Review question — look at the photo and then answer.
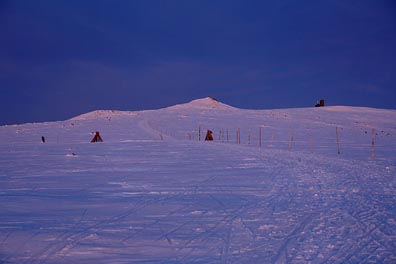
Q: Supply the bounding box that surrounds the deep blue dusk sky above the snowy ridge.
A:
[0,0,396,124]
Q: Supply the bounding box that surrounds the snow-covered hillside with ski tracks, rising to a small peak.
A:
[0,97,396,263]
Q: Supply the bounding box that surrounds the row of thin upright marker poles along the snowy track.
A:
[193,126,375,160]
